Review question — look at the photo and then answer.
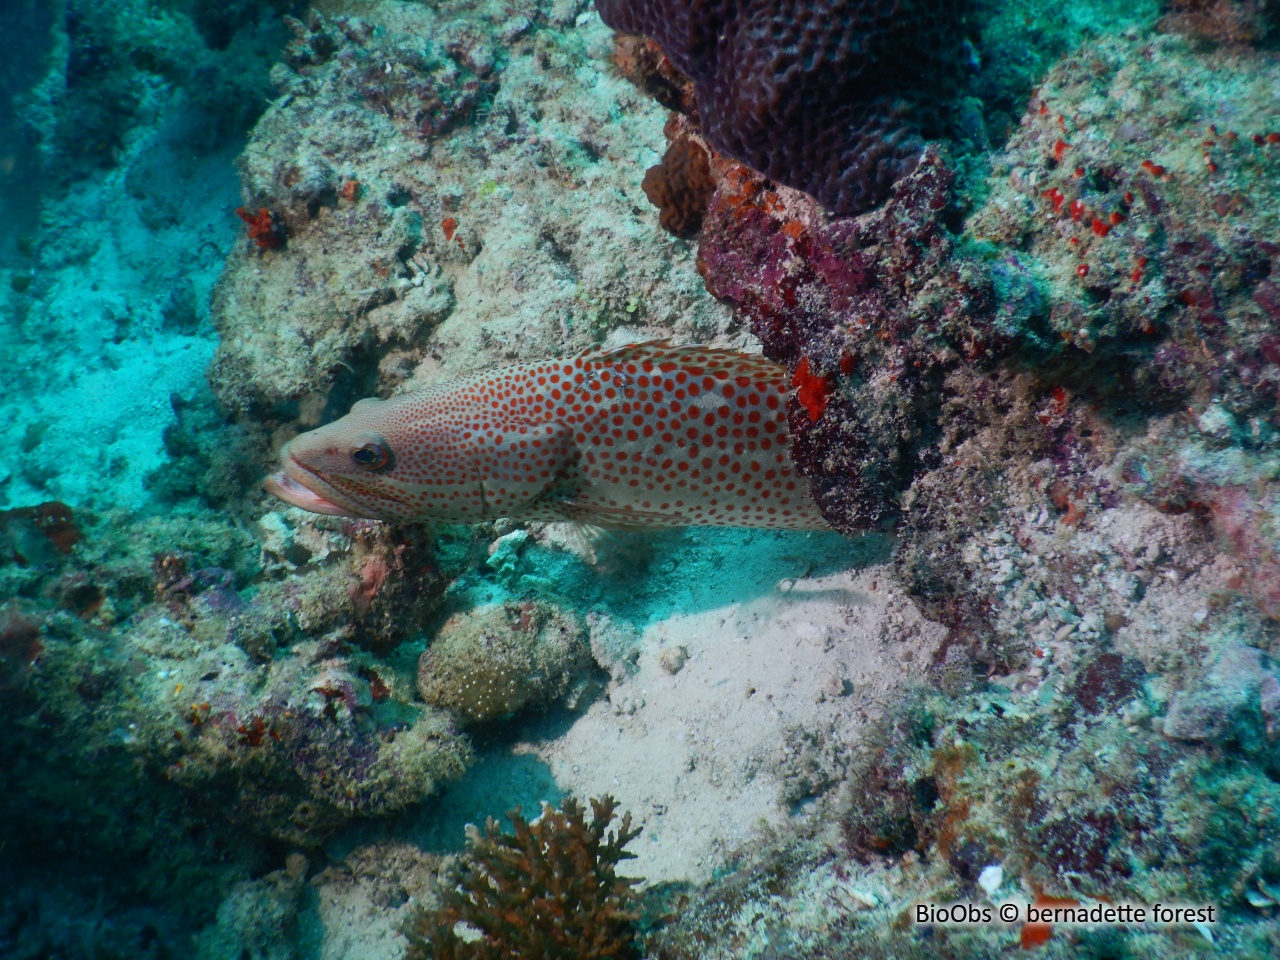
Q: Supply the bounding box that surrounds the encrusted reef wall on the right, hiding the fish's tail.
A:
[640,22,1280,959]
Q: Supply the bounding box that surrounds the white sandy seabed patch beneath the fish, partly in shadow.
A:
[314,526,945,960]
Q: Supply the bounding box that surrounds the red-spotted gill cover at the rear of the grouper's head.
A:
[463,424,573,517]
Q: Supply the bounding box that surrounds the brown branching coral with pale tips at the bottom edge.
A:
[404,796,640,960]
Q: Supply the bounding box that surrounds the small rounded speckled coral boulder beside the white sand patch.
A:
[417,600,590,723]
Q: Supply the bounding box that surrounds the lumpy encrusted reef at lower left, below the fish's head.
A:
[0,504,468,844]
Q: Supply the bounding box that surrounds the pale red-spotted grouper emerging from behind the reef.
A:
[265,340,829,530]
